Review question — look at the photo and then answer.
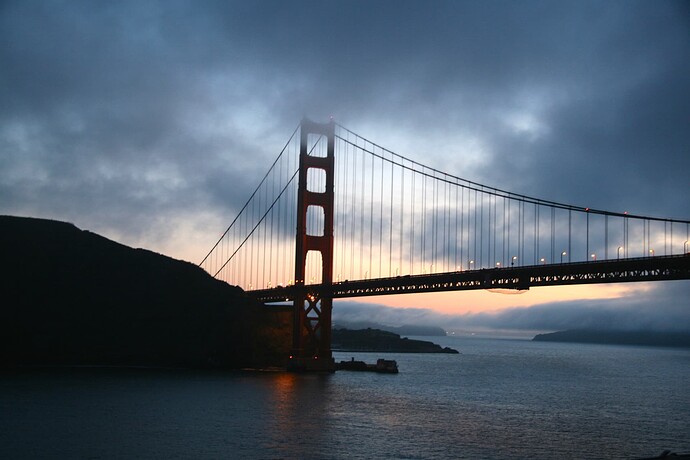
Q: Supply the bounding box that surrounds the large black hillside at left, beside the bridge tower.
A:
[0,216,289,368]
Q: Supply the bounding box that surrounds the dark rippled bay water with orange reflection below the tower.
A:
[0,337,690,459]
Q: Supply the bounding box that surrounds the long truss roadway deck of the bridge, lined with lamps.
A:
[248,253,690,303]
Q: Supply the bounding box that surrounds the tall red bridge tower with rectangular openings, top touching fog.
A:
[288,119,335,372]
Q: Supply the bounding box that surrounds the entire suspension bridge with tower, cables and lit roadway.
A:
[199,120,690,370]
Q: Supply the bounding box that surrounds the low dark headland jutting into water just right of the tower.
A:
[331,328,458,353]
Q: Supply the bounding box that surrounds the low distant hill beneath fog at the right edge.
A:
[532,329,690,347]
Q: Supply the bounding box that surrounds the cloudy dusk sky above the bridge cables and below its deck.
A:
[0,0,690,329]
